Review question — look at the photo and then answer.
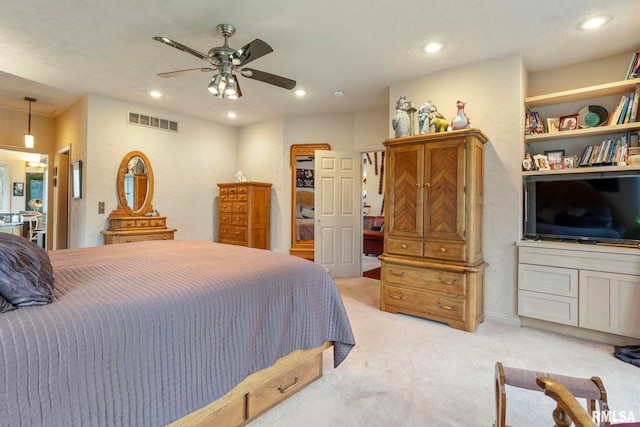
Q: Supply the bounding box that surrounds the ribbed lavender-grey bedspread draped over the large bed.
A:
[0,240,354,426]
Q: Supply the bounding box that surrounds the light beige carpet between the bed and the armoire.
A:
[250,278,640,427]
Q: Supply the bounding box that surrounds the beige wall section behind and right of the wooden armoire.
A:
[387,55,523,322]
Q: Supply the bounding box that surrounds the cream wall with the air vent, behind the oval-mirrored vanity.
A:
[59,94,238,247]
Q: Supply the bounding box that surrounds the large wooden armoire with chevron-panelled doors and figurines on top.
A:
[379,129,488,332]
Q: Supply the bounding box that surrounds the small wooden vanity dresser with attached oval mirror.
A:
[102,151,176,245]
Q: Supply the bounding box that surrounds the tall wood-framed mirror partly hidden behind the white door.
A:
[289,144,331,261]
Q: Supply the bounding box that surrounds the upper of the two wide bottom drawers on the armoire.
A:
[381,262,466,296]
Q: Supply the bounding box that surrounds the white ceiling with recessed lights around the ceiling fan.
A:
[0,0,640,126]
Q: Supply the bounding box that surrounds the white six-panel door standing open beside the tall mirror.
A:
[314,150,362,278]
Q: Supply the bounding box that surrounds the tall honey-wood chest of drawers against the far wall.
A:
[218,182,271,249]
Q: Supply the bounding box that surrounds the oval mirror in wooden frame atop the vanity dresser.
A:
[117,151,153,216]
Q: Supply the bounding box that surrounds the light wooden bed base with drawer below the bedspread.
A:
[169,342,333,427]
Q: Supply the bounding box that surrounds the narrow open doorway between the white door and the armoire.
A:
[362,151,384,279]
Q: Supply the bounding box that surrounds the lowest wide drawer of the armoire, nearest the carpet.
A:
[382,285,465,320]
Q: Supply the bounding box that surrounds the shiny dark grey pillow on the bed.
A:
[0,233,54,307]
